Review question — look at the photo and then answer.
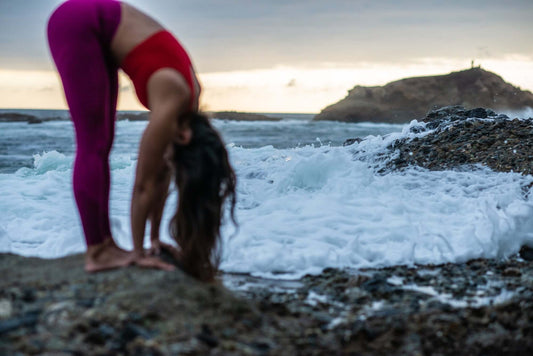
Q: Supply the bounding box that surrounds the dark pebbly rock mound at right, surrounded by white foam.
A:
[380,106,533,174]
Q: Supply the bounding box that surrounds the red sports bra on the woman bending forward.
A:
[121,30,195,109]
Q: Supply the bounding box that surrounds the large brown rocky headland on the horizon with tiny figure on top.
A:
[314,67,533,123]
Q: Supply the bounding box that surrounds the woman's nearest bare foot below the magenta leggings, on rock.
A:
[85,238,133,273]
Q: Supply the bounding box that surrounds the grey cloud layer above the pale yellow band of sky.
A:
[0,0,533,72]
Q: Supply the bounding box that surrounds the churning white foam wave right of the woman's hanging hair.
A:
[217,138,533,278]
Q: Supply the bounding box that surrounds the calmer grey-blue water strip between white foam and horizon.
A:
[0,110,402,173]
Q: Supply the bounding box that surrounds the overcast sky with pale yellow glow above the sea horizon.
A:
[0,0,533,112]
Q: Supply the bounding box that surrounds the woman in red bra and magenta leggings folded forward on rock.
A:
[48,0,235,280]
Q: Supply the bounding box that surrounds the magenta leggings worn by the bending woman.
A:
[48,0,120,245]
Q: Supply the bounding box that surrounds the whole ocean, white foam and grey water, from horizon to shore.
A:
[0,110,533,279]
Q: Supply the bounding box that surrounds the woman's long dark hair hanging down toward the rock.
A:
[170,113,236,281]
